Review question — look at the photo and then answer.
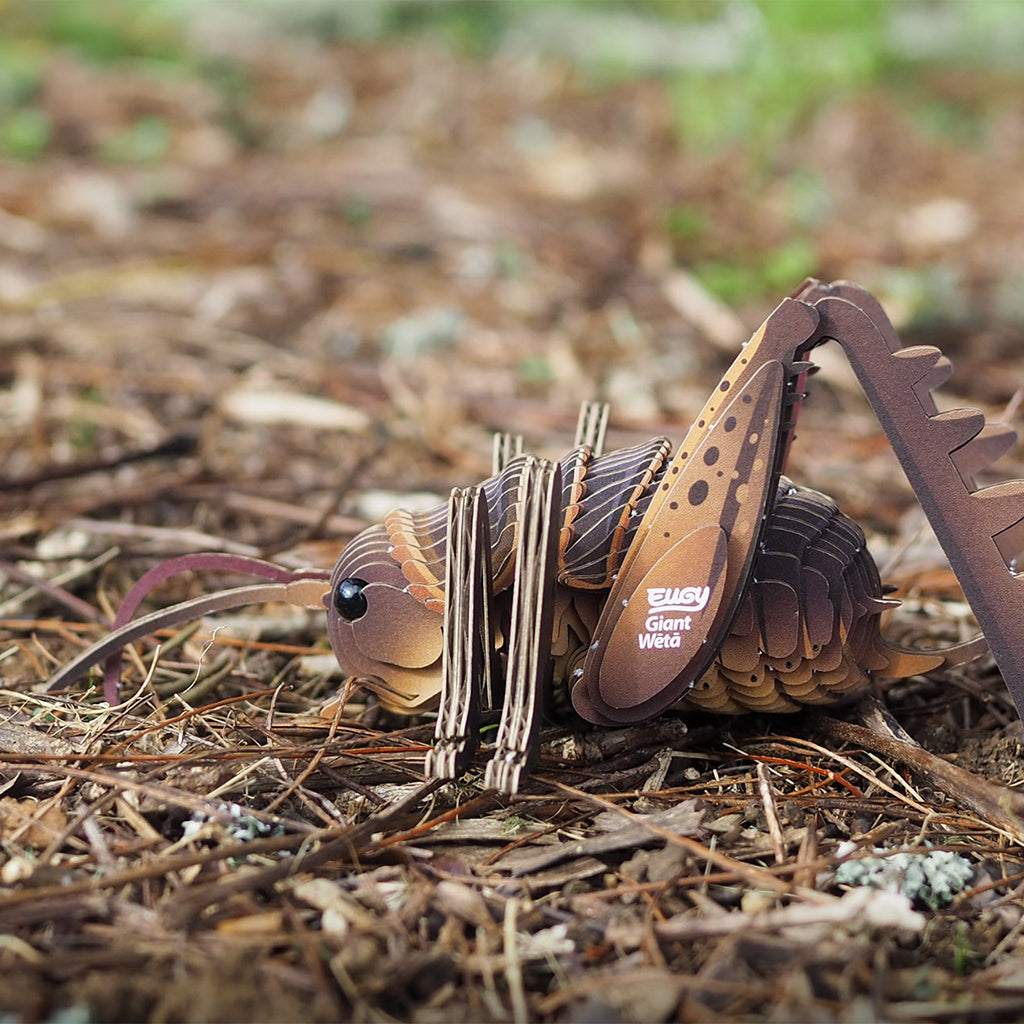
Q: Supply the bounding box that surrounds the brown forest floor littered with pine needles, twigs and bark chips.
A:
[0,10,1024,1021]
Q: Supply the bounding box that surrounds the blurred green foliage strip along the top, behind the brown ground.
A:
[8,0,1024,148]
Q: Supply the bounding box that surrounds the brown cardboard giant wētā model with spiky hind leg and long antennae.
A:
[51,281,1024,792]
